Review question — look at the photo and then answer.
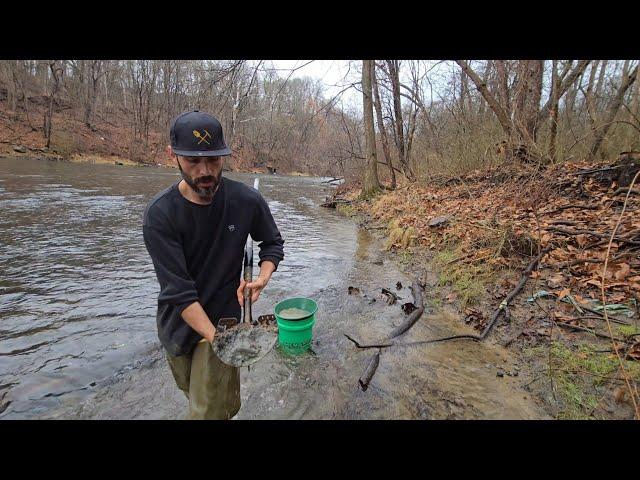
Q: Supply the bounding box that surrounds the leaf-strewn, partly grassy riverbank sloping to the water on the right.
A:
[337,158,640,419]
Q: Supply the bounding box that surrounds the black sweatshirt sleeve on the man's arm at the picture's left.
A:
[142,207,199,314]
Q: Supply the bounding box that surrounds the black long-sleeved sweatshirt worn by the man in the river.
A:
[142,177,284,356]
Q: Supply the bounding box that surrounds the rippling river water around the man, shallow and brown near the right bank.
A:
[0,159,544,419]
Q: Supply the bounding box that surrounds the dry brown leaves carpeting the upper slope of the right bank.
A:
[352,158,640,303]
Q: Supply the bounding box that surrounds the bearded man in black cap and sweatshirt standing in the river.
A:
[143,110,284,419]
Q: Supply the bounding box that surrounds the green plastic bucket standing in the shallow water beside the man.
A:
[274,297,318,355]
